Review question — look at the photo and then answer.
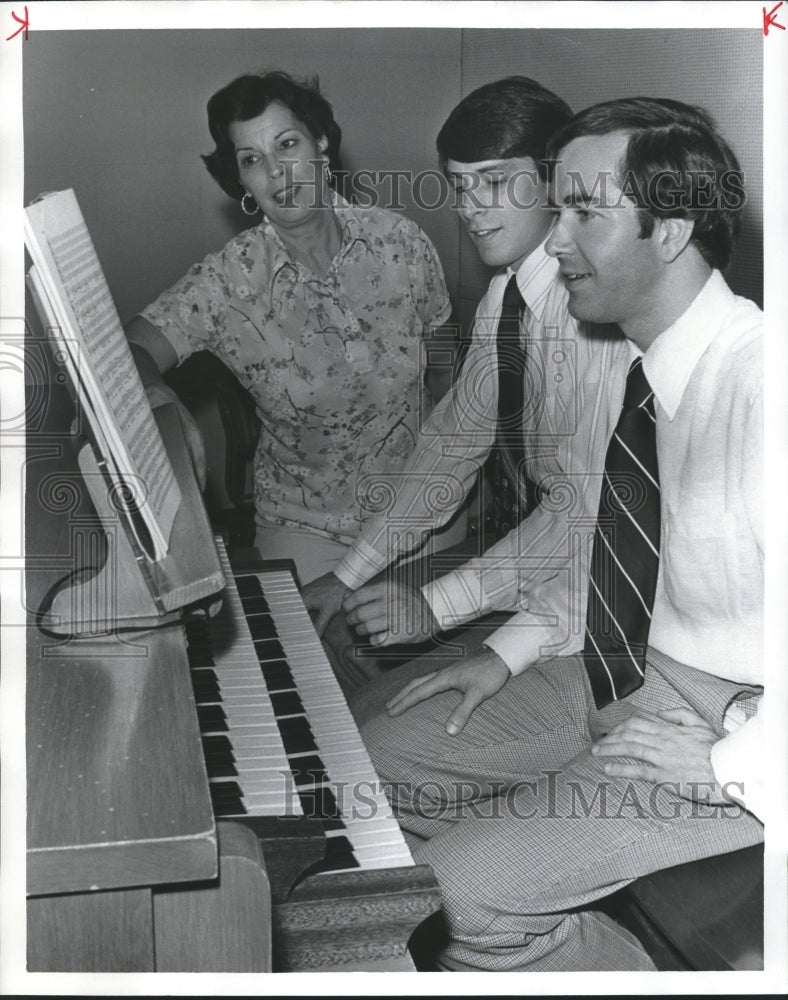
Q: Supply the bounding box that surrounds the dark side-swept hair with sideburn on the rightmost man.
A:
[547,97,745,270]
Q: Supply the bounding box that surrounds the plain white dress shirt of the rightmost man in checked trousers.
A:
[487,271,764,815]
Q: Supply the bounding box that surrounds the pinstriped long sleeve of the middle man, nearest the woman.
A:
[334,292,498,589]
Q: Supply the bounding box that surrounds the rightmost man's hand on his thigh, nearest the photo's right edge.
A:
[591,708,731,804]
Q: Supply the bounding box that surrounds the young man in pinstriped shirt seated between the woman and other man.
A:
[304,76,628,688]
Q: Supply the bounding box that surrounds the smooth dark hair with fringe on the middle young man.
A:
[436,76,572,177]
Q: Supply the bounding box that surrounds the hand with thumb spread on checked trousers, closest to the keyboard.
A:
[386,649,511,736]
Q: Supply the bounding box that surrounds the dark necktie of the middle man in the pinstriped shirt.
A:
[485,275,535,541]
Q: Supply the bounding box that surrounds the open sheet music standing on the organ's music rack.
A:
[25,190,181,561]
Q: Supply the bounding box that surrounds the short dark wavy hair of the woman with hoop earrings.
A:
[202,70,342,200]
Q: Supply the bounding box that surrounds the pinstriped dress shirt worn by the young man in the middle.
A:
[334,244,629,628]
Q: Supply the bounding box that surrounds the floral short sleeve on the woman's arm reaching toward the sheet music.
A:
[141,253,231,364]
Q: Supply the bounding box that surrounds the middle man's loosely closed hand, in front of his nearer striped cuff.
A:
[342,580,440,646]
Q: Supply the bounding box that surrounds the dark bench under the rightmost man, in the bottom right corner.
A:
[604,844,763,971]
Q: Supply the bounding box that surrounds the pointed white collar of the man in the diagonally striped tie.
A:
[643,271,735,420]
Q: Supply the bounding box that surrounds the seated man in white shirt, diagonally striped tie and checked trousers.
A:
[363,98,765,971]
